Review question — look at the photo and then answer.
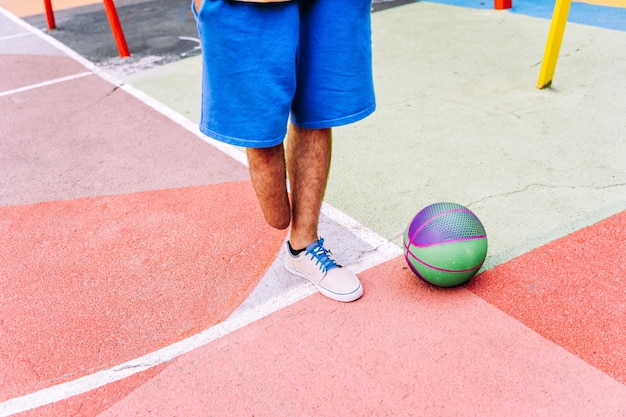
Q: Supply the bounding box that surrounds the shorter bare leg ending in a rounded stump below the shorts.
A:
[246,143,291,229]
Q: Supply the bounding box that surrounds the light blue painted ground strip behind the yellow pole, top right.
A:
[426,0,626,32]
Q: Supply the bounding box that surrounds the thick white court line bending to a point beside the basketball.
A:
[0,7,402,417]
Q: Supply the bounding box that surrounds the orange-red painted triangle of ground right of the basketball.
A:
[468,211,626,384]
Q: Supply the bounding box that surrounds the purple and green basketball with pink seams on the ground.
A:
[404,203,487,287]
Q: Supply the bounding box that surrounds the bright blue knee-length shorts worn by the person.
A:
[192,0,376,148]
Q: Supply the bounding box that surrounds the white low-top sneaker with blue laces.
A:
[285,238,363,303]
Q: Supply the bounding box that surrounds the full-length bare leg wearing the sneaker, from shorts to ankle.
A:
[287,124,332,249]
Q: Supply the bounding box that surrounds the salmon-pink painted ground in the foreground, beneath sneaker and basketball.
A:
[97,258,626,416]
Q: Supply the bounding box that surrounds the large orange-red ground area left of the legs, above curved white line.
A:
[0,181,285,401]
